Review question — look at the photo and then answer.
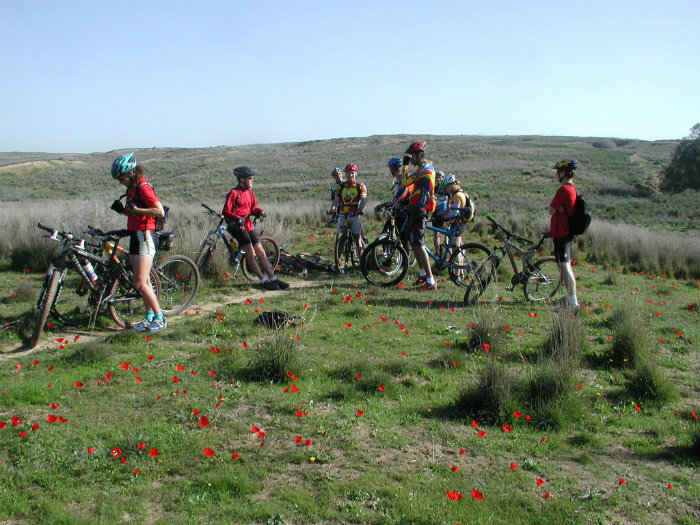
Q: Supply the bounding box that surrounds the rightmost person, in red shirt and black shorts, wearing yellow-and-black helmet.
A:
[549,159,578,308]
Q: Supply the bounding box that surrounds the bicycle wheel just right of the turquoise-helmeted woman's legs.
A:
[155,255,199,315]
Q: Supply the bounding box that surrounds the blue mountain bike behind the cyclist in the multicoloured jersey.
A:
[360,208,489,287]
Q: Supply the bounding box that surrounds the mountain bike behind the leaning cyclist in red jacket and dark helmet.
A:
[195,203,280,281]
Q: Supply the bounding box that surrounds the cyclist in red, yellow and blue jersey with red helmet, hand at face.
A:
[401,142,437,290]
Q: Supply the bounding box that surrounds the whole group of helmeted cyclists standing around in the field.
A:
[111,142,578,332]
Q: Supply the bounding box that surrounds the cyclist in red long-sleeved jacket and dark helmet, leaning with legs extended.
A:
[221,166,289,290]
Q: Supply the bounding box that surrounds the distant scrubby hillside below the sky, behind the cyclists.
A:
[0,135,697,230]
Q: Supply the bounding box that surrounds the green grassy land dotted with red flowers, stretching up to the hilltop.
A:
[0,137,700,524]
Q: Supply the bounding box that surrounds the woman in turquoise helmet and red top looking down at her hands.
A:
[110,151,168,332]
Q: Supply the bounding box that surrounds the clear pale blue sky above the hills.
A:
[0,0,700,153]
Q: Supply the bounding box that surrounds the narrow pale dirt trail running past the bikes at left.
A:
[0,280,327,361]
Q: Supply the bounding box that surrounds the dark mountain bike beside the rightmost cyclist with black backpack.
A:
[464,216,561,305]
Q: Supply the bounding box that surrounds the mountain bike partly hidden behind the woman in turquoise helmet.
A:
[86,226,200,316]
